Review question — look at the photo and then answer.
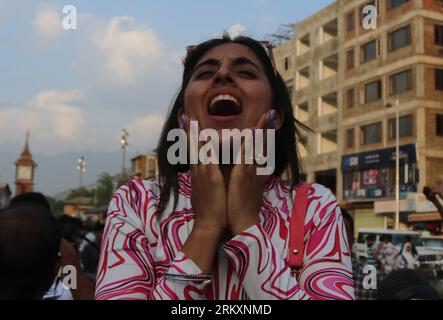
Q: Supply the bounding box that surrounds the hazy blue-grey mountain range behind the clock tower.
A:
[0,150,136,198]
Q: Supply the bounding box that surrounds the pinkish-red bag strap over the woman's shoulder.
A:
[288,183,311,274]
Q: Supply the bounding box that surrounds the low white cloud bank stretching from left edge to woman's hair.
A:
[0,90,164,155]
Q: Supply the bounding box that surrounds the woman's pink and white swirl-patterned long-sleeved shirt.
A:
[96,172,354,300]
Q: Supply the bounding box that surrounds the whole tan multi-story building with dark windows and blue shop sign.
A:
[275,0,443,234]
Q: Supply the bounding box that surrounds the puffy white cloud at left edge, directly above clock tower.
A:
[0,90,84,151]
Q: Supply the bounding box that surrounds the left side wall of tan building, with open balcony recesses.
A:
[275,3,340,193]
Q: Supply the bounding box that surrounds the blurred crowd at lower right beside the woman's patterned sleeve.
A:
[342,209,440,300]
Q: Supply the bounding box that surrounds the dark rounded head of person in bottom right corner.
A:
[378,269,440,300]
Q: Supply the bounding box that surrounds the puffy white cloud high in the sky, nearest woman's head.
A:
[95,16,164,85]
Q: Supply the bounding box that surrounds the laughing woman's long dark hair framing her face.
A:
[157,34,309,212]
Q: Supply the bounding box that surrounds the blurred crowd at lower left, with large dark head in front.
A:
[0,192,104,300]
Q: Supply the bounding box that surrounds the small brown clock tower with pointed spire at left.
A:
[15,131,37,195]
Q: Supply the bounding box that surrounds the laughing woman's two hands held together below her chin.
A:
[183,114,274,236]
